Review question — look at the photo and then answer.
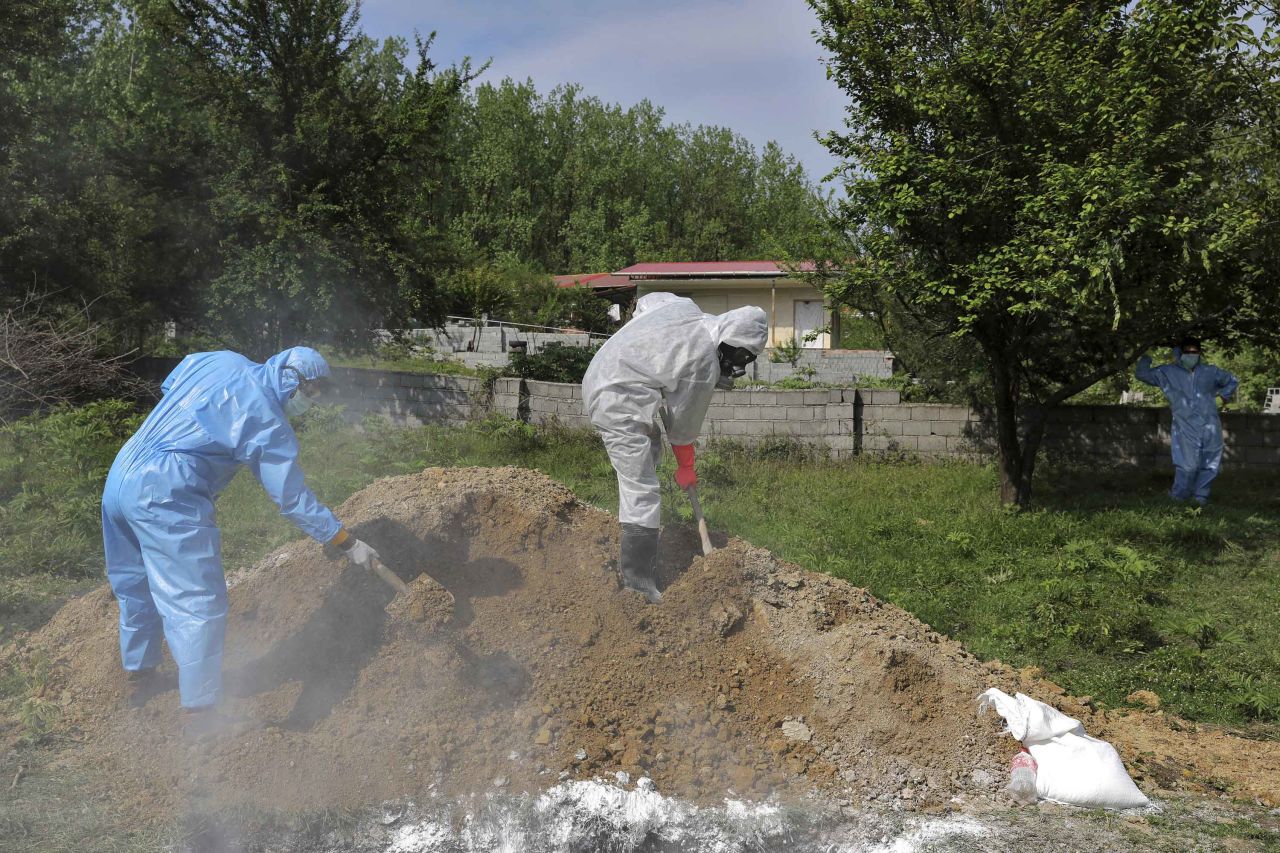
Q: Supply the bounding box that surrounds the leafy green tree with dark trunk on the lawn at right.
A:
[810,0,1280,505]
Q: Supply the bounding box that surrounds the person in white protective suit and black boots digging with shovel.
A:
[582,293,768,603]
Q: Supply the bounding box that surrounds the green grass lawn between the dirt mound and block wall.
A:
[0,410,1280,736]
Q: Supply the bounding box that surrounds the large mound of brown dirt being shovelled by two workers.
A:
[2,467,1280,815]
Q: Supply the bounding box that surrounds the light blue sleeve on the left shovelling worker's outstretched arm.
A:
[237,404,342,542]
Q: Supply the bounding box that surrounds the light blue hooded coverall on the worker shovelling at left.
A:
[102,347,342,708]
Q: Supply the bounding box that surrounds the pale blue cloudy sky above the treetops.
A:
[361,0,845,188]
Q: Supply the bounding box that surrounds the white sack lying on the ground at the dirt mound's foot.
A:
[978,688,1149,808]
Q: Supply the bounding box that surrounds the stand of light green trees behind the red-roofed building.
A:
[448,79,822,273]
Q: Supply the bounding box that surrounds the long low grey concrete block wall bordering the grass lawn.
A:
[127,359,1280,470]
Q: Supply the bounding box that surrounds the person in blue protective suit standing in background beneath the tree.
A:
[1135,338,1239,506]
